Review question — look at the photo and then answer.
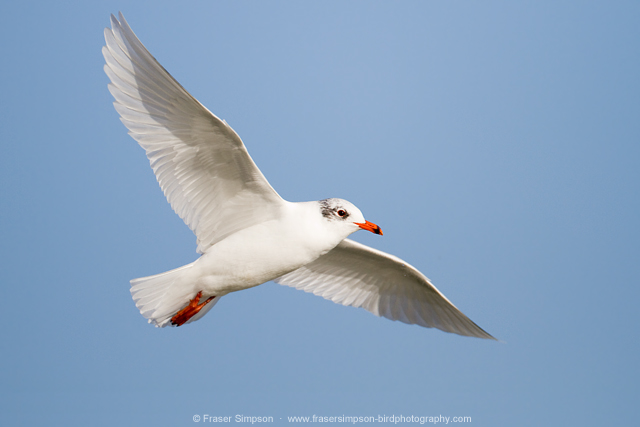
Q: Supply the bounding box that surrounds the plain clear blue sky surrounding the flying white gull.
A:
[0,1,640,426]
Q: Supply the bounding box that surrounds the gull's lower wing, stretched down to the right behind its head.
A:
[275,239,495,339]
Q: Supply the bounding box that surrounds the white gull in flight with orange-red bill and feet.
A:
[102,13,495,339]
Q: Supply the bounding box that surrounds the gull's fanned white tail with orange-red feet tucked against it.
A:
[131,263,220,328]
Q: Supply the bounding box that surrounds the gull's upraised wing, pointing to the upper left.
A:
[102,13,284,253]
